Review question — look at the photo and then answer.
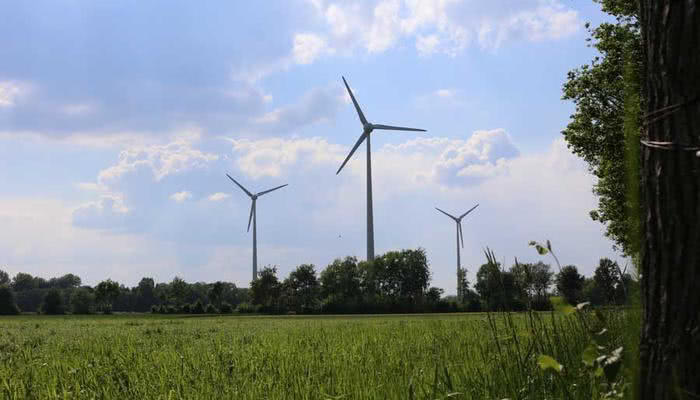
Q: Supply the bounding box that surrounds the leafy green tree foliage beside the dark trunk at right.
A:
[562,0,642,255]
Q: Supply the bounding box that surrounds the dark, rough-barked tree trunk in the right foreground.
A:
[639,0,700,399]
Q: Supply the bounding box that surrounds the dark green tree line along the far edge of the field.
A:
[0,249,638,314]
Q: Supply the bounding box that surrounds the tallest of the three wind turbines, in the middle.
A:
[335,77,425,261]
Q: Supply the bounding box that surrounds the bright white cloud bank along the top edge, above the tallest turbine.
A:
[294,0,581,64]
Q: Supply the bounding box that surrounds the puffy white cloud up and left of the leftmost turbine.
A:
[97,130,219,184]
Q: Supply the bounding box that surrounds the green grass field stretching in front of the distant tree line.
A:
[0,312,636,399]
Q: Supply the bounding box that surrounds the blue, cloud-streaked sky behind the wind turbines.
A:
[0,0,621,293]
